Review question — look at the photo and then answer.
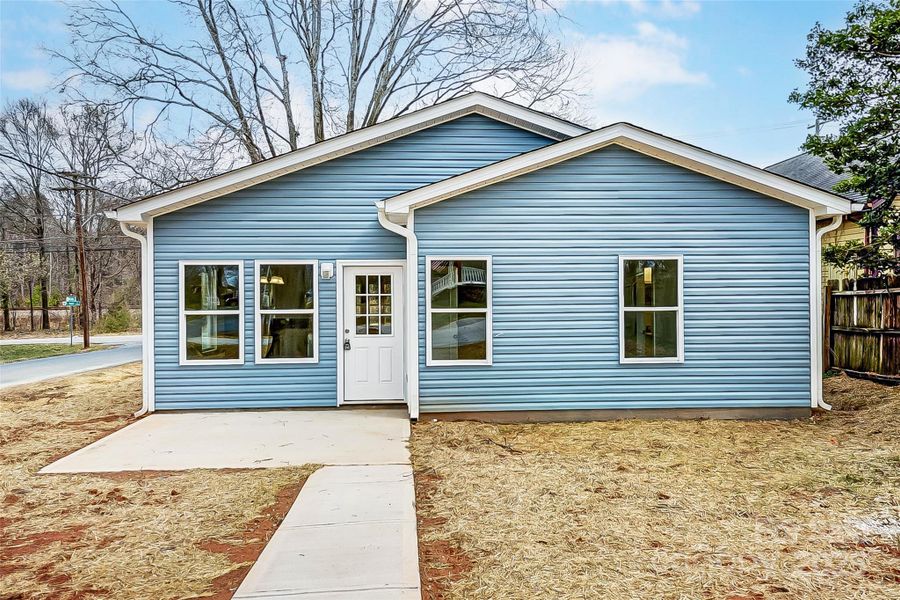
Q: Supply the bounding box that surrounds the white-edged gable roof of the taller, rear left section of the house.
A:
[107,92,590,223]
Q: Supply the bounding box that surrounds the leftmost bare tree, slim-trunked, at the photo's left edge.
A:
[0,99,58,329]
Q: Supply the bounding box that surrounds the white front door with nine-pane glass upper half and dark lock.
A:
[342,266,403,402]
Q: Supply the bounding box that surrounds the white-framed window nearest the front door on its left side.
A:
[255,260,319,363]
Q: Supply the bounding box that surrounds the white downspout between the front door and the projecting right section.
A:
[375,202,419,420]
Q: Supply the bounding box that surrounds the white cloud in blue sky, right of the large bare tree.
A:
[574,21,709,102]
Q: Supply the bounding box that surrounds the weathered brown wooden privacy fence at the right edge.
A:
[823,277,900,381]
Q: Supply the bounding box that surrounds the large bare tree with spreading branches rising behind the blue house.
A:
[57,0,575,162]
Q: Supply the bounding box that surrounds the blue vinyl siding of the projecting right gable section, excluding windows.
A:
[415,146,810,412]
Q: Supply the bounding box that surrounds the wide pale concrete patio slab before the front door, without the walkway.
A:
[40,408,410,473]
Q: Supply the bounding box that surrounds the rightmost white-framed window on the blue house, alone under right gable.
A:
[619,256,684,363]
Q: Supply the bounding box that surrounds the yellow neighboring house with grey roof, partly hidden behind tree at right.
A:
[766,152,869,284]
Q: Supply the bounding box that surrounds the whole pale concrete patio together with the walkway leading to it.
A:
[41,408,421,600]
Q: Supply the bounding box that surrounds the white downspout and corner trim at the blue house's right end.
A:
[809,211,844,410]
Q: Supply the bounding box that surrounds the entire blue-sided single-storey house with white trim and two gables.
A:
[110,94,851,420]
